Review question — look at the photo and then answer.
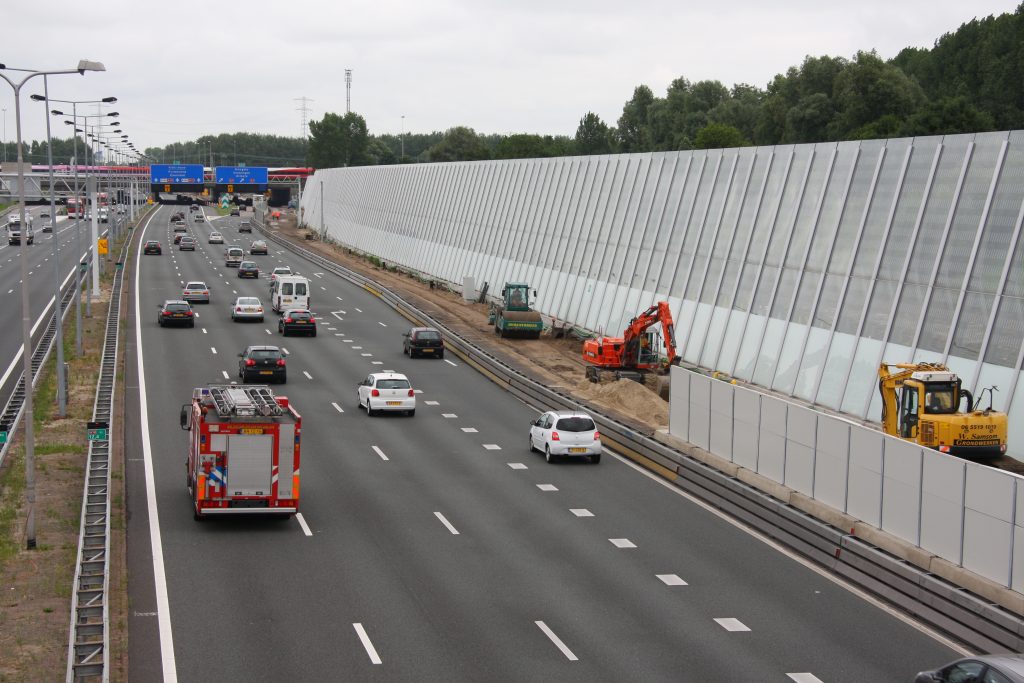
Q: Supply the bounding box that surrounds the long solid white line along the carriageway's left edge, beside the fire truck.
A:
[135,211,178,683]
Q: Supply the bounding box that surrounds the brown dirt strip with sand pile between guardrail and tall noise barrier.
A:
[269,215,669,433]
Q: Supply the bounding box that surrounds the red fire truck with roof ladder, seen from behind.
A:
[181,384,302,520]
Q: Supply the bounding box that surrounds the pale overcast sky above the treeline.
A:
[0,0,1018,156]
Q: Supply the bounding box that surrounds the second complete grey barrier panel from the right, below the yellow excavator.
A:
[921,451,967,564]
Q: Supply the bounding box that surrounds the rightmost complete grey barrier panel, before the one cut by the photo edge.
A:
[964,463,1017,586]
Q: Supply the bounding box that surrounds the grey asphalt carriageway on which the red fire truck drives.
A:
[125,207,958,683]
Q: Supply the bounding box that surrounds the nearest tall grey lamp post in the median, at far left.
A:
[0,59,106,550]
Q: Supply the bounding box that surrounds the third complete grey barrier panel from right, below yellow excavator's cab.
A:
[882,437,924,545]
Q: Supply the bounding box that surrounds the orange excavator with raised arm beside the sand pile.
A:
[583,301,679,383]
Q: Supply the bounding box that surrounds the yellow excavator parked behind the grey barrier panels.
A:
[879,362,1007,458]
